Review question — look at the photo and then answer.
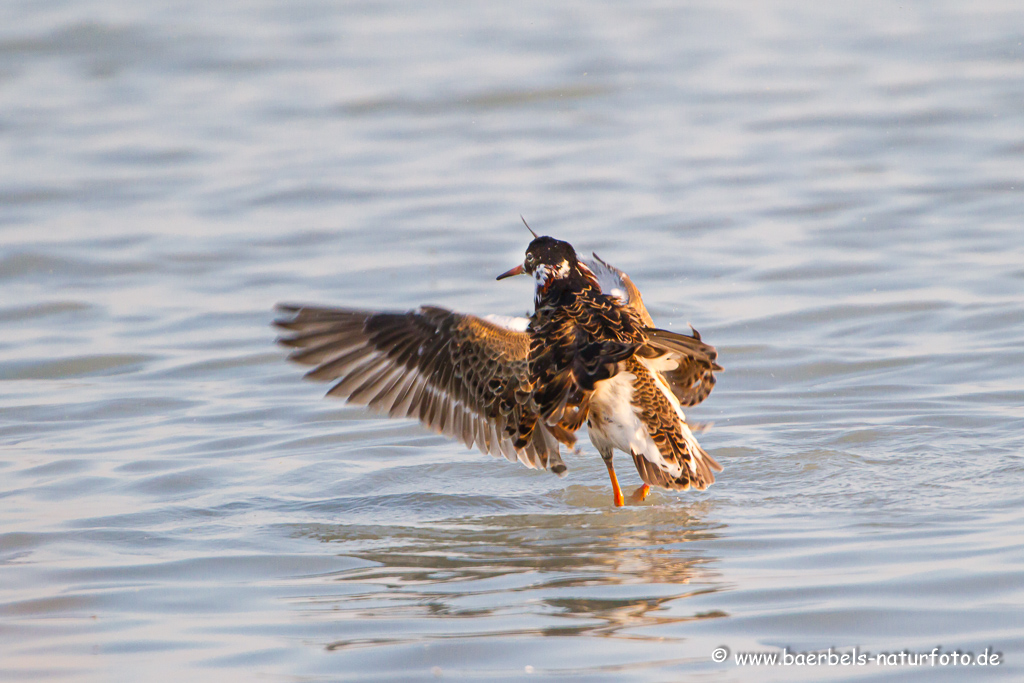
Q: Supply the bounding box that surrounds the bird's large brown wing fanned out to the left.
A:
[274,304,565,474]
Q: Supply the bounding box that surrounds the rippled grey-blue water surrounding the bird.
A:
[0,1,1024,681]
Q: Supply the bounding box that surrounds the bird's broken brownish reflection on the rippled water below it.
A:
[290,503,726,650]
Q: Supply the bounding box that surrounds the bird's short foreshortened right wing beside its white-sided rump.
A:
[639,328,722,407]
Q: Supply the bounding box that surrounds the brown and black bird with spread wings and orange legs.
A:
[273,227,722,507]
